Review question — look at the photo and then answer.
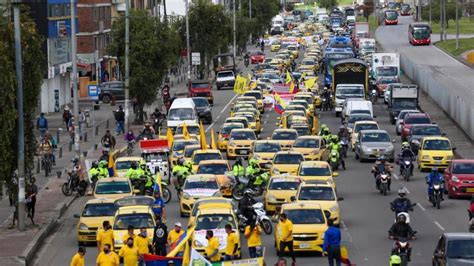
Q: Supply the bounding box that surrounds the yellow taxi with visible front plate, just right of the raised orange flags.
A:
[227,128,257,160]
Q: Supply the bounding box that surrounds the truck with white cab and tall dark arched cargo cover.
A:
[332,58,369,116]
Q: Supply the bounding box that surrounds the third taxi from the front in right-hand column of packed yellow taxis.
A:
[297,161,339,189]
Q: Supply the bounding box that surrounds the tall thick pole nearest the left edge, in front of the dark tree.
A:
[13,1,26,231]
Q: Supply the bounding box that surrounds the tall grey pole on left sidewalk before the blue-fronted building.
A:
[70,0,81,159]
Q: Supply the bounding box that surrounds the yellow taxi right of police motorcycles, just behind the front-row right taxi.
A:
[263,175,301,213]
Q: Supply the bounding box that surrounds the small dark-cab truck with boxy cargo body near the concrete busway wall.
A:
[387,83,420,124]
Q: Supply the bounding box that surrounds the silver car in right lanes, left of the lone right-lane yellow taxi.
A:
[355,130,395,162]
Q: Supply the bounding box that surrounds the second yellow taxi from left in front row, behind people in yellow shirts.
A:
[112,196,156,252]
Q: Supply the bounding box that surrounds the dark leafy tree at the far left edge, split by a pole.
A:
[0,5,46,195]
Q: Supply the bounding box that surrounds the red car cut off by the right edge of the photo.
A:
[444,160,474,198]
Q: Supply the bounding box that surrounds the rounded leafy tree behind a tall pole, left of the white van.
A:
[108,10,180,123]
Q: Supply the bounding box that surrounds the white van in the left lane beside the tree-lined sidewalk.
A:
[167,98,199,132]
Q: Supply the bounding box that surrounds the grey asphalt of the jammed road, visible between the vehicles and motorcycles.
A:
[32,46,468,266]
